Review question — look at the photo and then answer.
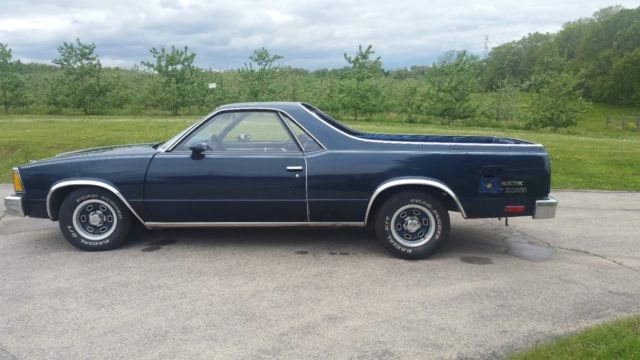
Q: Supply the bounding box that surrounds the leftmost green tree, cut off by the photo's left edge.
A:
[0,43,31,113]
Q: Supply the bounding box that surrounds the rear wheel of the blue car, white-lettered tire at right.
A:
[375,191,450,260]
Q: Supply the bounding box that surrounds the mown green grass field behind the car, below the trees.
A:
[0,105,640,190]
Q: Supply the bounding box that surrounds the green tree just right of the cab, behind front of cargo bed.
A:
[340,45,383,120]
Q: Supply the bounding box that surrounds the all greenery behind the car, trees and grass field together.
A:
[0,7,640,190]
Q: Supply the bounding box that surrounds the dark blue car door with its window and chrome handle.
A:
[144,111,308,223]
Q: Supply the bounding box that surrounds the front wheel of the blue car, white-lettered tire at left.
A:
[58,188,131,251]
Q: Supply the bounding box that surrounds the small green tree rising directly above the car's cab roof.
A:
[240,47,284,101]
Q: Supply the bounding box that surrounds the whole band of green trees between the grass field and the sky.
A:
[0,7,640,128]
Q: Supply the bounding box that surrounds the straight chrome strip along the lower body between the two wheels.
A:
[144,222,365,229]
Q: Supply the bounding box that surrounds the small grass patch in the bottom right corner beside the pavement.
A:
[509,316,640,360]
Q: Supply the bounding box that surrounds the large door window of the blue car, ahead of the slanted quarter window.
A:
[171,111,300,153]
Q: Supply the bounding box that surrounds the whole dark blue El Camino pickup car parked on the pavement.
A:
[5,103,557,259]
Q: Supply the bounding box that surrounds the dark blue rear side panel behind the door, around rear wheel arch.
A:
[307,147,550,221]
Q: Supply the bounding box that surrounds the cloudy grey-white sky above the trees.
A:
[0,0,640,70]
